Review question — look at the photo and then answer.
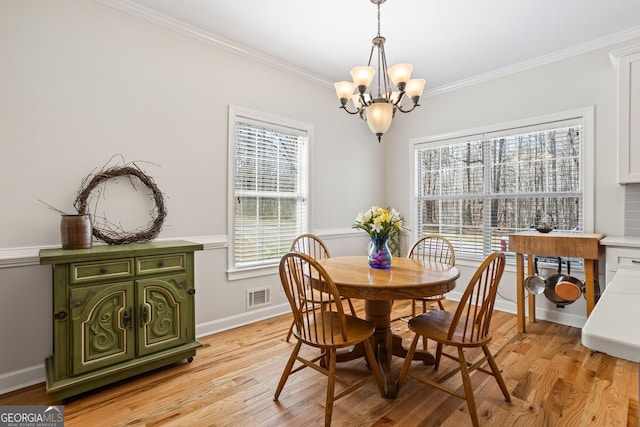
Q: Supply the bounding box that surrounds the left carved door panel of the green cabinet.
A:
[69,281,135,374]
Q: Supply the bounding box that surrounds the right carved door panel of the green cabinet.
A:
[136,274,193,355]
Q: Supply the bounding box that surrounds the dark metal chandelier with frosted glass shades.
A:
[334,0,425,142]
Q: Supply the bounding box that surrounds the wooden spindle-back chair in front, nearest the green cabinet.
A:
[273,252,384,426]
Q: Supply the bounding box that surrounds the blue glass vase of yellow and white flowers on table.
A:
[353,206,405,268]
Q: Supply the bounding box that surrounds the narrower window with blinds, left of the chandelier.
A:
[229,107,311,275]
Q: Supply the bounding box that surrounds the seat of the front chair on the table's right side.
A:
[409,310,491,347]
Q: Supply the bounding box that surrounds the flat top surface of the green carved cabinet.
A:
[40,240,203,264]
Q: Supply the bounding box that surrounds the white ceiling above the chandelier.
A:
[117,0,640,91]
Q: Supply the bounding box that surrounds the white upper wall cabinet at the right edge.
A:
[611,45,640,184]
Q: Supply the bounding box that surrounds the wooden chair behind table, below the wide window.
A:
[407,234,456,317]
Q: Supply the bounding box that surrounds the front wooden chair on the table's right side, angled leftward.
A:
[398,252,511,426]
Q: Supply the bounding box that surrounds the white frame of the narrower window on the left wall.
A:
[227,105,313,280]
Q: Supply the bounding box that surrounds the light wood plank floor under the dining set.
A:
[0,302,638,427]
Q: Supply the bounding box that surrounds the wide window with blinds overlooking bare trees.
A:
[414,110,593,259]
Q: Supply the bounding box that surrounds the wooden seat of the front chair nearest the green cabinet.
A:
[293,311,375,348]
